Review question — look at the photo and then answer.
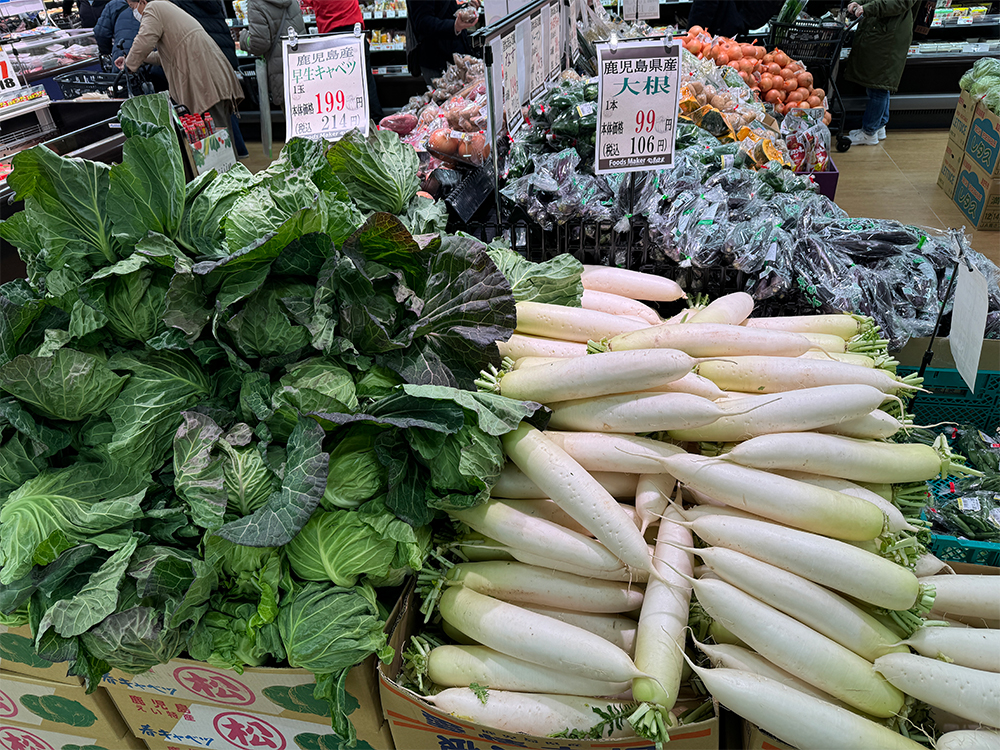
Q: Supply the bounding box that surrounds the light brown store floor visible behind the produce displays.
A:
[243,130,1000,265]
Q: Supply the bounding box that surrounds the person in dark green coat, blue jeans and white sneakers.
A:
[844,0,923,146]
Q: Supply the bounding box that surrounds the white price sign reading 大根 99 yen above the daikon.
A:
[594,39,681,174]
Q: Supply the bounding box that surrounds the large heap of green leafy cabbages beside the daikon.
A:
[0,96,537,738]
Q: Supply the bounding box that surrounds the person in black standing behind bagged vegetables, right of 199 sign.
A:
[406,0,479,86]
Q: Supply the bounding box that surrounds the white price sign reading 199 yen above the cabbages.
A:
[282,34,369,141]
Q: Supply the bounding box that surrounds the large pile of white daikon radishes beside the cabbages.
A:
[410,267,1000,750]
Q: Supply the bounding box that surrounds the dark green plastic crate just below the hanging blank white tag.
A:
[898,367,1000,431]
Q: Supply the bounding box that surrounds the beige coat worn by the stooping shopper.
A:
[125,0,243,112]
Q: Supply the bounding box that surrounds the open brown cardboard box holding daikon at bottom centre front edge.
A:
[379,592,719,750]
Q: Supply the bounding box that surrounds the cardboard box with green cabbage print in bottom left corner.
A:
[0,672,129,747]
